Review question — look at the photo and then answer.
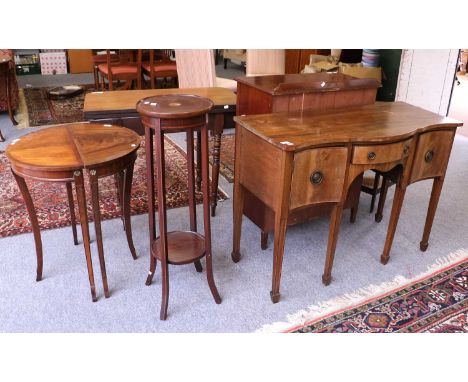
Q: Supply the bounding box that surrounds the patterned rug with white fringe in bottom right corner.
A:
[260,251,468,333]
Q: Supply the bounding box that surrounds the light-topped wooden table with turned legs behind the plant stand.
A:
[83,87,236,216]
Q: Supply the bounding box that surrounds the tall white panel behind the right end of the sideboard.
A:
[396,49,458,115]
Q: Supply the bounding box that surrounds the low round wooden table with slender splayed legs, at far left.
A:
[6,123,141,301]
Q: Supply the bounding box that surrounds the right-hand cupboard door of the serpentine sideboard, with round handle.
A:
[410,129,455,183]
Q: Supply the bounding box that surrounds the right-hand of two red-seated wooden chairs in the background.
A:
[138,49,177,89]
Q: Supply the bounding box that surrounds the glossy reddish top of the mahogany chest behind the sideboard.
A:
[235,72,380,95]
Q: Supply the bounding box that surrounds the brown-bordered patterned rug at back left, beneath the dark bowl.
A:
[19,85,94,127]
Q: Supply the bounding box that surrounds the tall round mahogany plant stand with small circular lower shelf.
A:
[137,94,221,320]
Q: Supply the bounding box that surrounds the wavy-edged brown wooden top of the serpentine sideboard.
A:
[234,102,463,151]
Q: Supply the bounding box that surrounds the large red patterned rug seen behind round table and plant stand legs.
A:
[0,138,227,237]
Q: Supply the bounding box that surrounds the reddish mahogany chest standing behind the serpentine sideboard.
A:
[236,72,380,249]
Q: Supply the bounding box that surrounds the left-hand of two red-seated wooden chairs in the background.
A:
[98,49,141,90]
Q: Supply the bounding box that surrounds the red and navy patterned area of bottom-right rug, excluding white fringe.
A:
[287,258,468,333]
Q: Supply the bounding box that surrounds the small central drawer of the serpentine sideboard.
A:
[351,139,411,164]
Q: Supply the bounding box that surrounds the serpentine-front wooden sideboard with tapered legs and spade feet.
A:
[232,102,462,303]
